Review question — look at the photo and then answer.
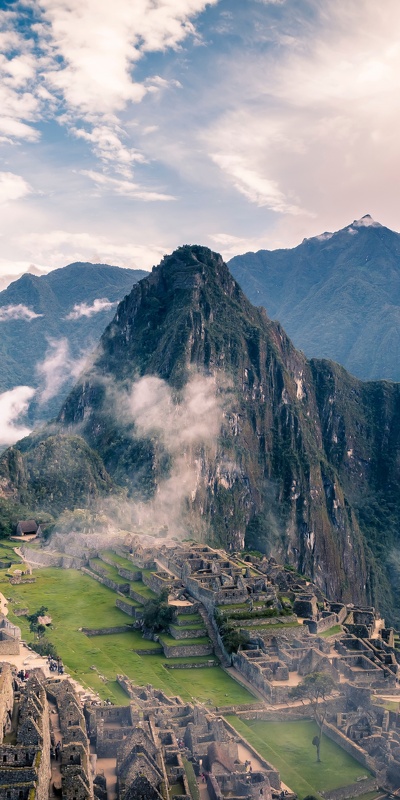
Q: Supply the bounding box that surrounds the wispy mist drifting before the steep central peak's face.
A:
[48,374,226,549]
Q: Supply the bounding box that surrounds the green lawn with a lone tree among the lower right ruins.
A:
[227,716,370,800]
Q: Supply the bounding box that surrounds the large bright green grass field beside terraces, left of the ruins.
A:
[0,568,255,705]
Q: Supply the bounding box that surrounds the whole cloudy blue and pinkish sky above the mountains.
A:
[0,0,400,278]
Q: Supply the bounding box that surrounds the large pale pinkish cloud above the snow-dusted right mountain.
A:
[198,0,400,236]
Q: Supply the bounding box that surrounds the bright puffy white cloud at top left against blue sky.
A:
[30,0,218,175]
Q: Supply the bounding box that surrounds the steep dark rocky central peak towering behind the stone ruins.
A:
[0,246,400,620]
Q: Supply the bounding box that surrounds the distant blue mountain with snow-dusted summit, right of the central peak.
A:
[228,215,400,381]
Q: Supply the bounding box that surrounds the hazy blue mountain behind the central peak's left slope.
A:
[0,262,147,421]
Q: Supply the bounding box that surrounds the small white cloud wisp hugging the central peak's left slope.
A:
[36,339,87,405]
